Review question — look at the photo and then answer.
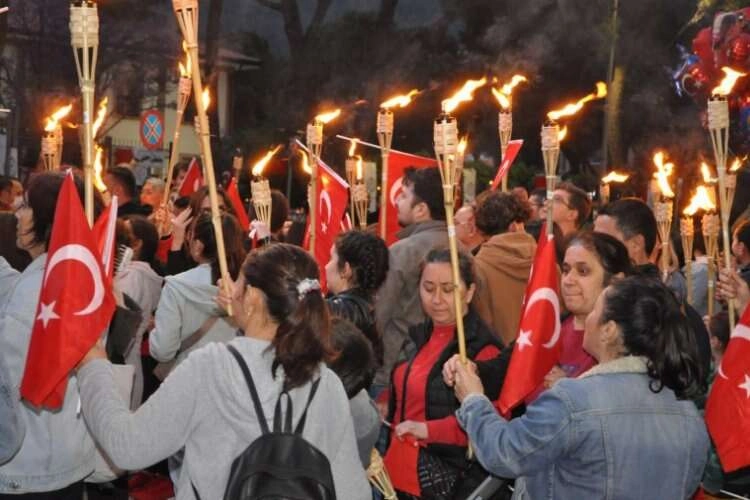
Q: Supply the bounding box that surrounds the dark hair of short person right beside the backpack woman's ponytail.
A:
[328,316,375,399]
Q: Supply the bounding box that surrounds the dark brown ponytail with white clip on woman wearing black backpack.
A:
[242,243,333,389]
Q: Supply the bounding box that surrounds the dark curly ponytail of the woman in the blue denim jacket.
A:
[601,276,706,399]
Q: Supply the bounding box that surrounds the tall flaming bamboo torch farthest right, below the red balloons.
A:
[708,67,745,330]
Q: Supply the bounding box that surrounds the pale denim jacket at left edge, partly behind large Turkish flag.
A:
[0,254,94,494]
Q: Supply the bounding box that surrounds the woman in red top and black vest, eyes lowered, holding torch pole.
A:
[386,249,510,499]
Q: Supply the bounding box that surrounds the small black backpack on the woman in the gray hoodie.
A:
[217,345,336,500]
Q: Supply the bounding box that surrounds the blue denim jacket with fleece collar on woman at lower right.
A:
[456,356,709,500]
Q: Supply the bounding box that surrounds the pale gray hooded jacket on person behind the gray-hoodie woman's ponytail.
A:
[148,264,236,363]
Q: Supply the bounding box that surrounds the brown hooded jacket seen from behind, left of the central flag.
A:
[472,232,536,345]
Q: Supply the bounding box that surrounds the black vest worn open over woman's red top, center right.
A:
[388,310,513,469]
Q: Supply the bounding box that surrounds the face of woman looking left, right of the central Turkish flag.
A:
[562,245,604,316]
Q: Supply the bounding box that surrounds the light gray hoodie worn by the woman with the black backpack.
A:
[78,337,372,500]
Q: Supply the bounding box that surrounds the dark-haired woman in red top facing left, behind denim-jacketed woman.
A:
[539,231,632,392]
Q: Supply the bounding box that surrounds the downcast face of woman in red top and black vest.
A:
[419,262,474,325]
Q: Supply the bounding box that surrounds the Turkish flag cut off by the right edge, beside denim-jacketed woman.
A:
[706,307,750,472]
